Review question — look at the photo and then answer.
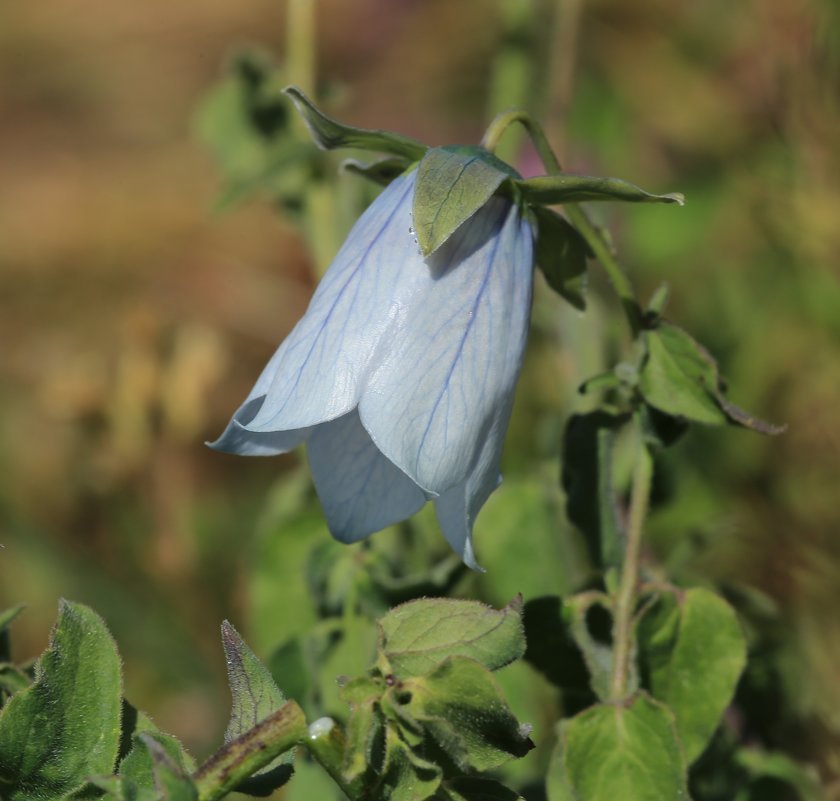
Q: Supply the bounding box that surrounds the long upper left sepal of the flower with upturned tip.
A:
[283,86,428,162]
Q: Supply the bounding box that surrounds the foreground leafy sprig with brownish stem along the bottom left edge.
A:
[0,599,532,801]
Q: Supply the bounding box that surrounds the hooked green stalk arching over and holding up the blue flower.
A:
[481,109,643,338]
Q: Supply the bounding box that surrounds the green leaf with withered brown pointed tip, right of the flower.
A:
[639,321,784,434]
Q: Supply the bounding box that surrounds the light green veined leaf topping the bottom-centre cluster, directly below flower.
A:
[377,598,525,678]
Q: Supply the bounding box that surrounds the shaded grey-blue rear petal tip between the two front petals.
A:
[307,410,426,542]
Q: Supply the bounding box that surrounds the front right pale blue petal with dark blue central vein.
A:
[359,198,533,494]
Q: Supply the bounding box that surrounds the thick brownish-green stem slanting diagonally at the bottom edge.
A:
[193,701,309,801]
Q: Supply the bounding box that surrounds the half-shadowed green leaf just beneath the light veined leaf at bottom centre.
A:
[390,656,533,772]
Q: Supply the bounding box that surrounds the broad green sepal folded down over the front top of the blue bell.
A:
[412,146,511,256]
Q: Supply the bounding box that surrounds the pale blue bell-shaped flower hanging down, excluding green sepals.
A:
[212,170,534,567]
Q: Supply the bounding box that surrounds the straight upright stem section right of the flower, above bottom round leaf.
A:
[610,431,653,701]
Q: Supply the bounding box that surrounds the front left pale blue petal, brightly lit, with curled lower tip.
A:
[246,171,423,431]
